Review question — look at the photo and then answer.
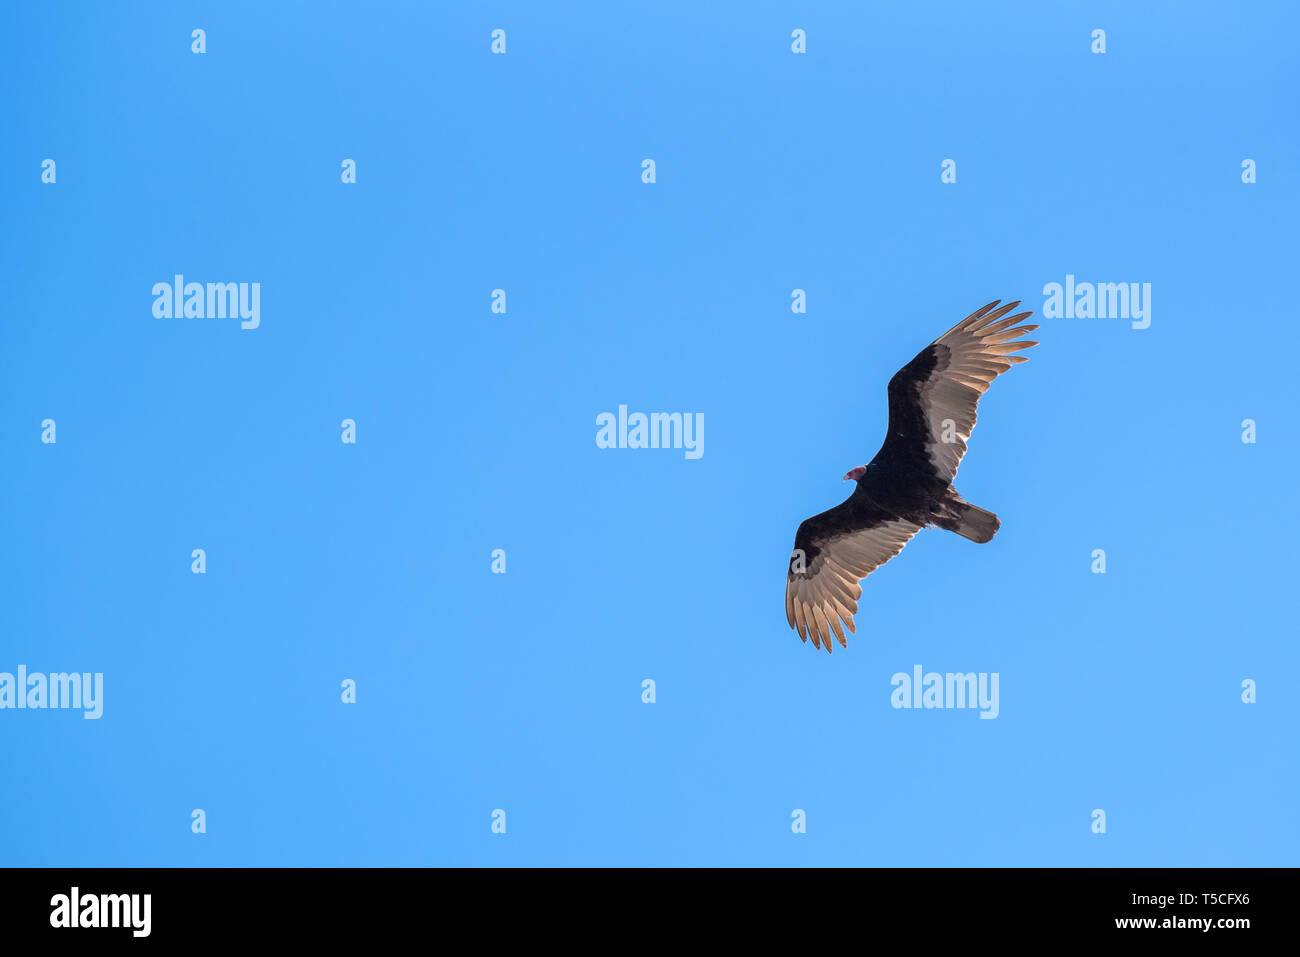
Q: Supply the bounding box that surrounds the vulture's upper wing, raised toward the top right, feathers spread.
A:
[879,299,1039,482]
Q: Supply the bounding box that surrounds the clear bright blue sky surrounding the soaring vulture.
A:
[0,3,1300,865]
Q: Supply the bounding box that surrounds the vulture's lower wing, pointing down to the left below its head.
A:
[785,493,920,651]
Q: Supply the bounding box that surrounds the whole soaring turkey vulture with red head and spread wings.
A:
[785,299,1039,651]
